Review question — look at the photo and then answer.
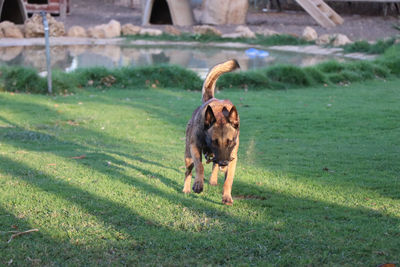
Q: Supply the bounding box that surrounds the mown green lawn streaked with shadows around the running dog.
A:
[0,80,400,266]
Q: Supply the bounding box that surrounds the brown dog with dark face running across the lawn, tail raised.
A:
[183,60,239,205]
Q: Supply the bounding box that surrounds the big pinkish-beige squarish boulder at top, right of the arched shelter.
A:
[200,0,249,25]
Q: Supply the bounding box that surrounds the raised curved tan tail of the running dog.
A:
[202,59,240,103]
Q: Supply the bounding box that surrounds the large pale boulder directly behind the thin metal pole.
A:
[24,14,65,38]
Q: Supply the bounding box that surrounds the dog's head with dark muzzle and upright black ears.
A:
[204,105,239,167]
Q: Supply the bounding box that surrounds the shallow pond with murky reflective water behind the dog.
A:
[0,44,345,77]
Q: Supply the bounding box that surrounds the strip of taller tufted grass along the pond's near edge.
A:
[0,45,400,94]
